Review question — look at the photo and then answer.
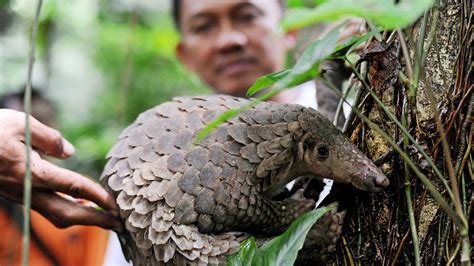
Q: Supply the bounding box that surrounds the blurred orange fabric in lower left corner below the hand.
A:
[0,209,109,266]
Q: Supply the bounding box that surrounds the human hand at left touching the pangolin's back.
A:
[0,109,122,231]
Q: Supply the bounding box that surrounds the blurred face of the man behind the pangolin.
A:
[176,0,294,96]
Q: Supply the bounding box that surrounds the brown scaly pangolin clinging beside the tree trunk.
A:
[101,95,389,265]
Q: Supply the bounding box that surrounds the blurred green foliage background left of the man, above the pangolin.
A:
[0,0,211,178]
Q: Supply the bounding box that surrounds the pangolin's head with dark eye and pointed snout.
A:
[298,109,390,192]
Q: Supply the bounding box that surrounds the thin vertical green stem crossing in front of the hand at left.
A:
[21,0,43,266]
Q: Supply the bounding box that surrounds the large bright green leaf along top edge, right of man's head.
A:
[283,0,433,30]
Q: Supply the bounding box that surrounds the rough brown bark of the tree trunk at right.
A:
[332,0,473,265]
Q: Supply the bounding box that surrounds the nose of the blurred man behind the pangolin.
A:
[215,25,248,53]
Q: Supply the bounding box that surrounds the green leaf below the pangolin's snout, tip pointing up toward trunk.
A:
[252,207,331,266]
